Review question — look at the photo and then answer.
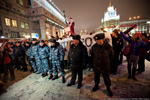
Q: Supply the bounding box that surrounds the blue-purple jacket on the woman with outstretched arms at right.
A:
[120,32,150,56]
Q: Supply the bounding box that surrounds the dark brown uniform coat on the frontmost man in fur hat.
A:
[91,43,114,73]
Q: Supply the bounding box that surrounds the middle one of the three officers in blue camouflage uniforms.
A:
[38,40,52,77]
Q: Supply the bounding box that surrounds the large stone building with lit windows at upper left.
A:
[0,0,66,39]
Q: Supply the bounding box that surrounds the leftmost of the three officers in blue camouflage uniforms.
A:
[26,38,42,74]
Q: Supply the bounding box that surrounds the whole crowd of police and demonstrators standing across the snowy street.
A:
[0,26,150,96]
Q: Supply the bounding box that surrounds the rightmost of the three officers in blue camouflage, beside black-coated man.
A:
[49,38,65,83]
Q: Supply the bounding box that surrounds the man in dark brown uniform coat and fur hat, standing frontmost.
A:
[91,33,114,96]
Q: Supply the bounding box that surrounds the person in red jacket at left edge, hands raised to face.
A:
[0,42,15,83]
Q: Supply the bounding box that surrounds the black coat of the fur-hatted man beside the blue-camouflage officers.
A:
[67,41,88,71]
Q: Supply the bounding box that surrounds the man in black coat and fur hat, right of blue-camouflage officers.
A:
[67,35,88,89]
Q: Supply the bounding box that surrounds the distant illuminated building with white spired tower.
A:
[95,2,150,33]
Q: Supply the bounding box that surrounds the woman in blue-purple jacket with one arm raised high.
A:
[118,29,148,80]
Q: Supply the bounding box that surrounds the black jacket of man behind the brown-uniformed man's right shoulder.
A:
[112,36,123,54]
